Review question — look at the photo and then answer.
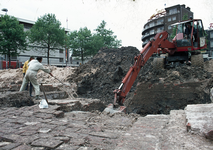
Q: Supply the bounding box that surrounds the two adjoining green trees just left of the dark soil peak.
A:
[68,21,121,63]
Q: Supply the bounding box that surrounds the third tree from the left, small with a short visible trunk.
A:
[68,27,92,64]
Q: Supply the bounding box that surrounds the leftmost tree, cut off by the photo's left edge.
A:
[0,15,27,68]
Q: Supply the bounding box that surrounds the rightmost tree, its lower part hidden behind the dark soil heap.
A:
[95,20,121,48]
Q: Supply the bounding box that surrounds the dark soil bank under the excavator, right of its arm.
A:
[125,58,213,115]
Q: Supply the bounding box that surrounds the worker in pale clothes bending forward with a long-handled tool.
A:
[19,57,53,100]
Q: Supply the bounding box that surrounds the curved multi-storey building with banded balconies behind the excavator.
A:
[141,5,193,47]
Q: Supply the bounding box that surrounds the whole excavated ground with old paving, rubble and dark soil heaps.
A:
[0,46,213,150]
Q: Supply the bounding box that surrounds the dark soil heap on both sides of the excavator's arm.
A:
[68,47,213,115]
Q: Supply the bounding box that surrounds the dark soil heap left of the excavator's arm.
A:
[68,47,139,104]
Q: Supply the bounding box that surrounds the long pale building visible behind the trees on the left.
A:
[2,15,73,67]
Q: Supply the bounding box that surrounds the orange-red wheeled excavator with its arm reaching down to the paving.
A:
[105,19,207,113]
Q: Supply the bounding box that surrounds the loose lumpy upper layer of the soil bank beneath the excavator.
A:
[138,58,213,84]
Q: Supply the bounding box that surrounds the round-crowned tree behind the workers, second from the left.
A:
[29,14,66,65]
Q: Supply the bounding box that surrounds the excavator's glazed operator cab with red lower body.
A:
[171,19,206,51]
